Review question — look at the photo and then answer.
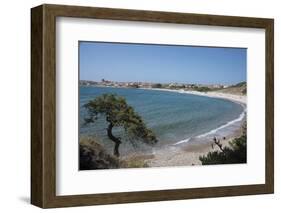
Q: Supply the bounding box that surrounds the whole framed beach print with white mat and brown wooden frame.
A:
[31,5,274,208]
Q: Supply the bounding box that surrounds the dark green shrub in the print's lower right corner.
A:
[199,124,247,165]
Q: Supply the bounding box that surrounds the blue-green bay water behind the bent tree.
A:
[79,87,244,155]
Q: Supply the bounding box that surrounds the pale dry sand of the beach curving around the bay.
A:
[139,88,247,167]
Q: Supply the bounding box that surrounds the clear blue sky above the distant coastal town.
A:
[79,41,247,84]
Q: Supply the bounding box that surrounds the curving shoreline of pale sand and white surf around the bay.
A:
[80,87,247,167]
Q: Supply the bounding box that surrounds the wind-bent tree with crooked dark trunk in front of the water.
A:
[84,94,157,157]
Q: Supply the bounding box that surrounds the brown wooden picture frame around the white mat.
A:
[31,5,274,208]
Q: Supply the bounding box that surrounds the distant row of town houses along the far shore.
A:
[80,79,228,89]
